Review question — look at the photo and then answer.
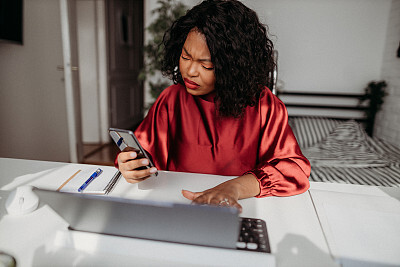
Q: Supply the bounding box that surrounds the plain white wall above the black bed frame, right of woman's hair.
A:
[244,0,391,92]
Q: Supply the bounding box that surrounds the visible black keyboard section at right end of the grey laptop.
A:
[236,218,271,253]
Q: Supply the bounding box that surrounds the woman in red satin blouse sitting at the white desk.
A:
[116,0,310,214]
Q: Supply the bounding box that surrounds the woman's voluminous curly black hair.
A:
[162,0,275,118]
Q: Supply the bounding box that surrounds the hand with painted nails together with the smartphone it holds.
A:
[109,128,158,183]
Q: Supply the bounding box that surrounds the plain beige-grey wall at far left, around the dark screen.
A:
[0,0,69,161]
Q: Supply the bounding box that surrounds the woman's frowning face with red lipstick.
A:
[179,29,215,95]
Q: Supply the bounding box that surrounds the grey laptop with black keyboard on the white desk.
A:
[33,188,270,253]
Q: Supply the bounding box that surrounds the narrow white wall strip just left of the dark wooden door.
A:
[76,0,109,144]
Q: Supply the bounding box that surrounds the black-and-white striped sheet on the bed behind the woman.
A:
[289,117,400,187]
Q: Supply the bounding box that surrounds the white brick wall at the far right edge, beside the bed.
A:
[375,0,400,147]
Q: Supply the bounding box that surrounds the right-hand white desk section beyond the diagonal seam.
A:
[309,183,400,266]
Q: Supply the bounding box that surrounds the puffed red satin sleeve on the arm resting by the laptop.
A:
[247,90,311,197]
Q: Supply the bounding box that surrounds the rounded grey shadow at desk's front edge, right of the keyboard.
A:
[276,234,339,267]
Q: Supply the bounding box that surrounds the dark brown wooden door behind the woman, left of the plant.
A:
[107,0,144,129]
